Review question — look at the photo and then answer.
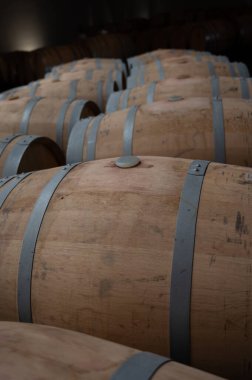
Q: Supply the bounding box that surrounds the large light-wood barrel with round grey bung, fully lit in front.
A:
[0,156,252,380]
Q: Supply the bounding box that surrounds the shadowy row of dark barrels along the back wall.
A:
[0,8,252,90]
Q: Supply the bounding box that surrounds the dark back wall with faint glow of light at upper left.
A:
[0,0,252,52]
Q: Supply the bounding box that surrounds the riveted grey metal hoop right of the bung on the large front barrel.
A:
[169,160,209,364]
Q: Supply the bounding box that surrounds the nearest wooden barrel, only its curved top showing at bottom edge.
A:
[0,322,224,380]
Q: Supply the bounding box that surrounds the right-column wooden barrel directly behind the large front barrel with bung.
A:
[67,97,252,166]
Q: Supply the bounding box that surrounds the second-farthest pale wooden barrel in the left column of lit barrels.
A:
[44,69,126,90]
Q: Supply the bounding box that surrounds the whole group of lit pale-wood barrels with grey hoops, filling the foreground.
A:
[0,50,252,380]
